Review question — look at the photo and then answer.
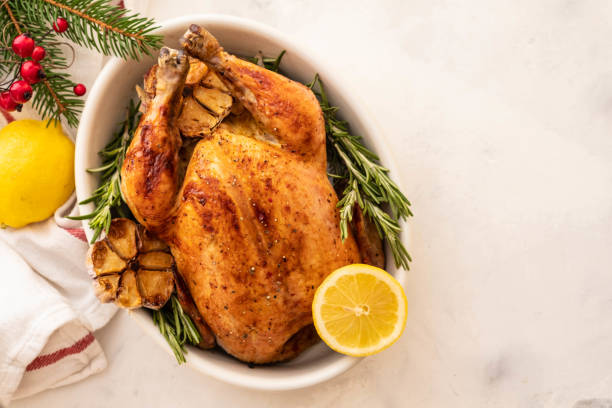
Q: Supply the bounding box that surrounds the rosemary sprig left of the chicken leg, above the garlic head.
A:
[68,100,141,244]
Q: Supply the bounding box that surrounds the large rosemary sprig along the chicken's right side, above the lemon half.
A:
[307,74,412,269]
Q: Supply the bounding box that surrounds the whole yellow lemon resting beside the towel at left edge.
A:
[0,119,74,228]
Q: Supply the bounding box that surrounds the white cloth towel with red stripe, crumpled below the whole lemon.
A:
[0,218,115,406]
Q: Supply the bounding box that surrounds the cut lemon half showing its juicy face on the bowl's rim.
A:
[312,264,408,356]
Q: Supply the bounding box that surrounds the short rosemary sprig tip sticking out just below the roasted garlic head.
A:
[153,295,202,364]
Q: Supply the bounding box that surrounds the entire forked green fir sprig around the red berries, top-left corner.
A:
[0,0,162,127]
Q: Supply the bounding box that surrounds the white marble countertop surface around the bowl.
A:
[12,0,612,408]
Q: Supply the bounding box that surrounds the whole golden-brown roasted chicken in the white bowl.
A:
[121,26,382,363]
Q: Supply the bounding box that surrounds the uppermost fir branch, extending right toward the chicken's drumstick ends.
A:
[12,0,162,59]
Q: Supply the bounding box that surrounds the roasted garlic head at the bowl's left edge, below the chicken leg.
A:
[87,218,175,309]
